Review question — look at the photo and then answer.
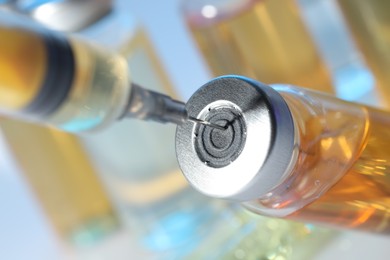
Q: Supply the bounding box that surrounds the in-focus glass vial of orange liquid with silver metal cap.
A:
[176,76,390,234]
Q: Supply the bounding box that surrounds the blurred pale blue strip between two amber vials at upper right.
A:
[299,0,379,106]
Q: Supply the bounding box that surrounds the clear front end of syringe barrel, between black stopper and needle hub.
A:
[47,40,130,132]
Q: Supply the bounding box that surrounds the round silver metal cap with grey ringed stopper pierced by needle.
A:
[176,76,295,201]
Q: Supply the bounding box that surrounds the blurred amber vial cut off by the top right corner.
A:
[337,0,390,108]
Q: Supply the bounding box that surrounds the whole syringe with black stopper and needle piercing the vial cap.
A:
[0,25,223,132]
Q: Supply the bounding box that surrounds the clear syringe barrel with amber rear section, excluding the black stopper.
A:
[0,22,130,132]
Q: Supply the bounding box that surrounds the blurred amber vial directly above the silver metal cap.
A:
[182,0,334,93]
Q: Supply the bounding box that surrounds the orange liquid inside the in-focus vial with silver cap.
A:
[288,109,390,234]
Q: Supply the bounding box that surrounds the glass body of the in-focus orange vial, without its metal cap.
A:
[246,85,390,233]
